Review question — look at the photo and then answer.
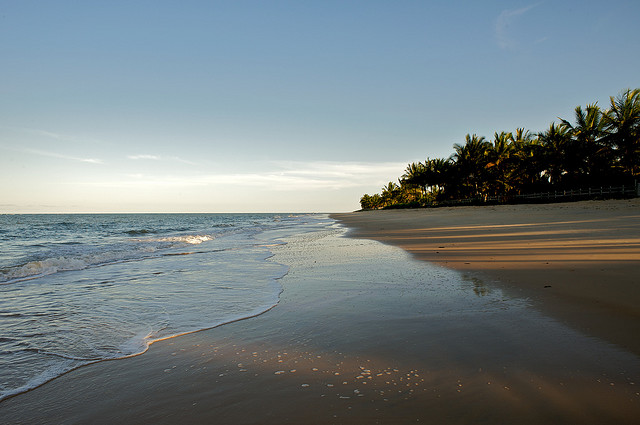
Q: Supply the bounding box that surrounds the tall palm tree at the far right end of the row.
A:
[604,89,640,177]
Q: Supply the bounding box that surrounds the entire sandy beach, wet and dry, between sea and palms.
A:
[0,204,640,424]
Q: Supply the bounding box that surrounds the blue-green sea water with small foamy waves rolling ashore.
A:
[0,214,332,400]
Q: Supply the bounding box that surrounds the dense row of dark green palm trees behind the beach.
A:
[360,89,640,209]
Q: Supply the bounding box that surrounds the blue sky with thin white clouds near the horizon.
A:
[0,0,640,213]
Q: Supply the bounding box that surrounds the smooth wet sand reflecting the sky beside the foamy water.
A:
[0,215,640,424]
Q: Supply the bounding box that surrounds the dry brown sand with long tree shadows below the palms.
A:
[331,198,640,355]
